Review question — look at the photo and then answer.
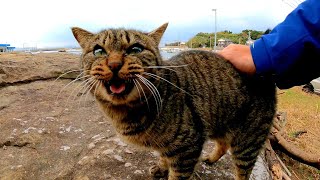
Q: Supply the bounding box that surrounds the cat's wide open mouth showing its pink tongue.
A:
[104,78,134,96]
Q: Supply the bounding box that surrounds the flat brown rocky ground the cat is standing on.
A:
[0,51,278,180]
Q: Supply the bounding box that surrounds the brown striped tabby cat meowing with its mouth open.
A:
[72,24,276,180]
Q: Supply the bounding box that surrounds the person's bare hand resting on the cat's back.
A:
[218,44,256,75]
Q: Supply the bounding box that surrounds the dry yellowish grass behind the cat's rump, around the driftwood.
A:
[278,87,320,179]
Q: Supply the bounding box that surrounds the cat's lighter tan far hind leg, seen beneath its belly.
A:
[202,139,229,164]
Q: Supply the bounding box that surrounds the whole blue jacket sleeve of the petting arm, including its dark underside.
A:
[250,0,320,88]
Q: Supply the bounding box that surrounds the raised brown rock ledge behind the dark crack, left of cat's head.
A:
[0,53,79,87]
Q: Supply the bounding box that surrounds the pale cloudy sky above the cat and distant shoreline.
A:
[0,0,302,48]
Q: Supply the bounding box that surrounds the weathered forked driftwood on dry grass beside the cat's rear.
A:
[265,110,320,180]
